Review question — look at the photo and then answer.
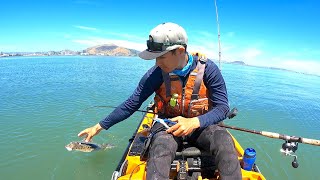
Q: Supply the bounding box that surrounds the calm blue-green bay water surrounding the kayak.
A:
[0,56,320,180]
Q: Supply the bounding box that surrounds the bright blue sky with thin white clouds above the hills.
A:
[0,0,320,74]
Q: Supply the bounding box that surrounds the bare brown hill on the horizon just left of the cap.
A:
[84,44,139,56]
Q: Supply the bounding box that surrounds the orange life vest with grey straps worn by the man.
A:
[154,54,211,118]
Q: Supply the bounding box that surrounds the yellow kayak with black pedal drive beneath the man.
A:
[111,105,265,180]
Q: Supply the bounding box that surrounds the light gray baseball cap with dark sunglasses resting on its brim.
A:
[139,22,188,60]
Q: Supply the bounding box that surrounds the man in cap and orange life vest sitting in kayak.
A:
[78,23,242,180]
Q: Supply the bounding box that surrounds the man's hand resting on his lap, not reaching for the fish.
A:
[167,116,200,136]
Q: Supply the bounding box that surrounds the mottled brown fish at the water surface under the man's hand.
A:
[65,141,114,152]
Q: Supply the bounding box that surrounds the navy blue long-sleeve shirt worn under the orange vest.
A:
[99,56,229,130]
